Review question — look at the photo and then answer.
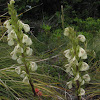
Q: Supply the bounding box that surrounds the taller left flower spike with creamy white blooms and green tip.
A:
[4,0,37,83]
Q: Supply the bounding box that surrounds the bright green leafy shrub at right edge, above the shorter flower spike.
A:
[72,17,100,34]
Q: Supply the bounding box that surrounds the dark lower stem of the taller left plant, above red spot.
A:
[22,53,36,96]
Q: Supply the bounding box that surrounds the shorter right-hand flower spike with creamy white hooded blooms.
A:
[64,27,90,96]
